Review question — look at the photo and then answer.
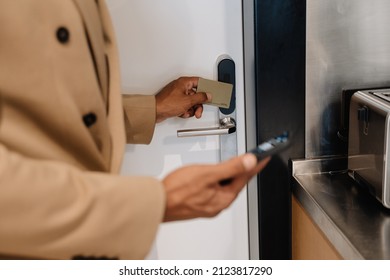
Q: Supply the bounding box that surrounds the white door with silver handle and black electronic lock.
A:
[107,0,249,259]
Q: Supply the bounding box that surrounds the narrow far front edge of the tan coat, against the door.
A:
[73,0,125,172]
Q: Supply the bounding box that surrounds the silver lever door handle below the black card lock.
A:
[177,117,236,137]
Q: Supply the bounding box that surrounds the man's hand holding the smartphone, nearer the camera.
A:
[163,153,270,222]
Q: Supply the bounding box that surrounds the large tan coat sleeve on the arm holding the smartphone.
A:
[0,143,165,259]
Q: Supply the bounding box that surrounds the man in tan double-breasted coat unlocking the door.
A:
[0,0,267,259]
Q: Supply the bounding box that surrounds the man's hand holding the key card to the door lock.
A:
[156,77,211,122]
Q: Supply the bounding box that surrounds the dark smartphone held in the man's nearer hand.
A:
[219,131,289,186]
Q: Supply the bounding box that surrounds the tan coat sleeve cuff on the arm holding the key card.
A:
[122,95,156,144]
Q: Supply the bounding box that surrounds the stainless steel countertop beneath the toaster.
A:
[292,157,390,260]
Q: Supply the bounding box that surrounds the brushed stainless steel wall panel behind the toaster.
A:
[305,0,390,158]
